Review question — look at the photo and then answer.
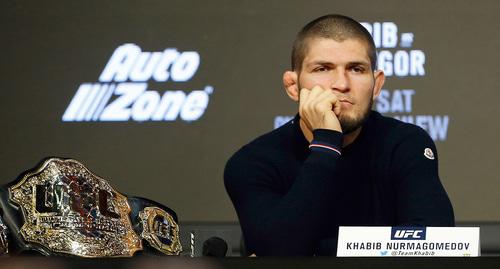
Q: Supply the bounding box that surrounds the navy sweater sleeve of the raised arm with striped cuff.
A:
[224,130,342,256]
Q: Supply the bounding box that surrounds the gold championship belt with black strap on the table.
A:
[0,158,181,258]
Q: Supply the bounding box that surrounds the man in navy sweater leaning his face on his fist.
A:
[224,15,454,256]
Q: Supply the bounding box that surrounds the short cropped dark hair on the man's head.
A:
[292,14,377,71]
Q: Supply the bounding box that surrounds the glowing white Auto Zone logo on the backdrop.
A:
[62,44,214,122]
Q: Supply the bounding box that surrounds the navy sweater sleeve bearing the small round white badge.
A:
[391,128,455,226]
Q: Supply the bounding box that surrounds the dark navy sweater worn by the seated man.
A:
[224,111,454,256]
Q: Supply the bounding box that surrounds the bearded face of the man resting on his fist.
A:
[298,38,382,134]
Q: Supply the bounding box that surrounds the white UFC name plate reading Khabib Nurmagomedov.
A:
[337,226,481,257]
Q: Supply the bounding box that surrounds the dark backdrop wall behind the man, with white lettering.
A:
[0,0,500,221]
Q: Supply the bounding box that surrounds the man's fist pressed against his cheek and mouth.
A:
[299,86,342,132]
